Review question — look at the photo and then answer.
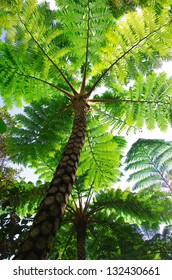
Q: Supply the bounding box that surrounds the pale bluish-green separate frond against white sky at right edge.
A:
[126,139,172,191]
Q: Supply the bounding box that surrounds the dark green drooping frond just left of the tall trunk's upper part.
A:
[8,96,72,167]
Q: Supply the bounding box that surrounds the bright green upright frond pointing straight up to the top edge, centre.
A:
[54,0,114,76]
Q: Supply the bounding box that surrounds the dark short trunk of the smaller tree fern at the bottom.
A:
[75,219,87,260]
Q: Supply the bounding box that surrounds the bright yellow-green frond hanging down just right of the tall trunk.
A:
[77,118,125,190]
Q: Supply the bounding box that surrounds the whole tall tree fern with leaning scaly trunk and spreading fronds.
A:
[0,0,171,259]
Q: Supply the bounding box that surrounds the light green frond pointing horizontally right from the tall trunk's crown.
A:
[92,72,172,132]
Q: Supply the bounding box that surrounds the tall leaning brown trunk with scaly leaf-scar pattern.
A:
[14,98,89,260]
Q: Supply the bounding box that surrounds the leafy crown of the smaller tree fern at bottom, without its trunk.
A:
[53,185,171,259]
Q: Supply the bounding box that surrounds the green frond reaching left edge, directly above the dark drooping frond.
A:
[0,42,69,107]
